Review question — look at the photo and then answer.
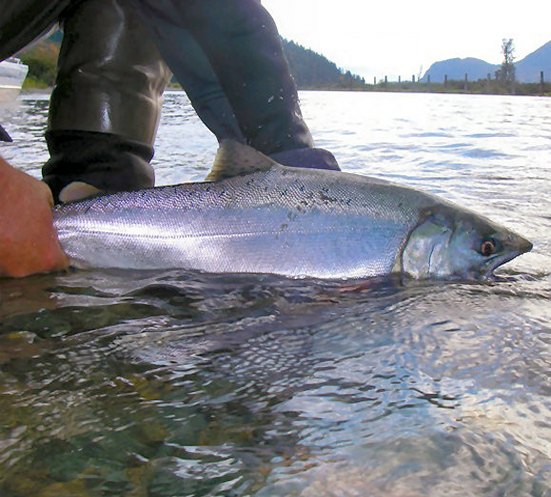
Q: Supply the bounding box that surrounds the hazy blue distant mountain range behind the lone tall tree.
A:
[421,41,551,83]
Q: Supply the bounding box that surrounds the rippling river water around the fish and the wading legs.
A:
[0,92,551,497]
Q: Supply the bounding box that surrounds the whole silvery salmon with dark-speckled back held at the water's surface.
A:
[54,143,531,279]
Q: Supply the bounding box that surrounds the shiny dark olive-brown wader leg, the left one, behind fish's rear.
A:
[42,0,171,201]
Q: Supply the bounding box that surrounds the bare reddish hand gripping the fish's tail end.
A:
[0,158,69,277]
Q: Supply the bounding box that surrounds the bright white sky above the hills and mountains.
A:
[262,0,551,82]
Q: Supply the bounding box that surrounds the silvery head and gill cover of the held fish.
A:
[401,206,532,281]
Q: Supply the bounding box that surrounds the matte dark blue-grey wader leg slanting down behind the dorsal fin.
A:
[134,0,339,170]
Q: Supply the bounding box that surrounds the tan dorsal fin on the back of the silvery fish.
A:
[205,140,279,181]
